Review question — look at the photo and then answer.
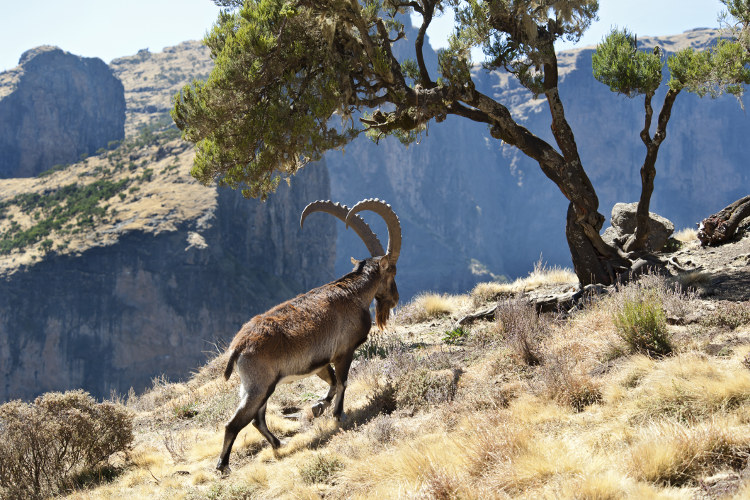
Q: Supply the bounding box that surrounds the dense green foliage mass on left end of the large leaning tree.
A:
[172,0,368,197]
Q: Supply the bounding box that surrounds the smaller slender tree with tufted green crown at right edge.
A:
[592,25,750,251]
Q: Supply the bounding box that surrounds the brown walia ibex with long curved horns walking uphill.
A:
[216,199,401,471]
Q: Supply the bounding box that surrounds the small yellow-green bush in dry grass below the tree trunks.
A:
[614,291,672,356]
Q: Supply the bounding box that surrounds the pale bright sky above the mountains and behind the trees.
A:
[0,0,723,71]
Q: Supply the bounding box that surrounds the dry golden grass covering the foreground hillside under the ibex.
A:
[51,270,750,499]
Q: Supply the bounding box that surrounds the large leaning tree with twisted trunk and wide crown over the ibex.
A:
[172,0,750,285]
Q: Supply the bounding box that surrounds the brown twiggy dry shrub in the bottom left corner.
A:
[0,390,133,498]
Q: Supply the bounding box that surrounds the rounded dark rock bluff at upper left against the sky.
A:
[0,46,125,178]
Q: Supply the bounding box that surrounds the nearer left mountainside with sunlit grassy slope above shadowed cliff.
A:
[0,44,336,401]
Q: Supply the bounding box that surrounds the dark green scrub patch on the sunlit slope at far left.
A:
[0,179,130,254]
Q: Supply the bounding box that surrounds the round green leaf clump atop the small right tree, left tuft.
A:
[591,29,662,97]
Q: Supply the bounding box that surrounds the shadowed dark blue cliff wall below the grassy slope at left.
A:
[0,158,335,401]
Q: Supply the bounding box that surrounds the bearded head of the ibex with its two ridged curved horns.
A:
[300,198,401,329]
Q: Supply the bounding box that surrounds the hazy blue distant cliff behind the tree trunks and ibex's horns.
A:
[326,30,750,297]
